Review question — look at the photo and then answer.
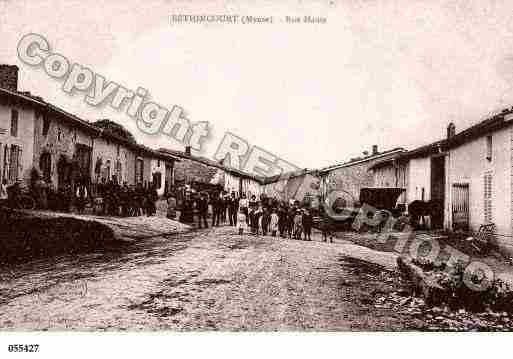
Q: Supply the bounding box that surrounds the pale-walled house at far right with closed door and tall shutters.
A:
[444,114,513,253]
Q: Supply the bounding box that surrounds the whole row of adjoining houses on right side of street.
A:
[372,114,513,246]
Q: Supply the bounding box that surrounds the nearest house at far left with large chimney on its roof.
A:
[0,65,98,190]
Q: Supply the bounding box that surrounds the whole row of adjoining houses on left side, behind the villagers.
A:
[0,65,178,194]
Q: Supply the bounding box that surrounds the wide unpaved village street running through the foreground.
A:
[0,226,424,330]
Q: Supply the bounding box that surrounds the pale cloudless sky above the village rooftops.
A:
[0,0,513,168]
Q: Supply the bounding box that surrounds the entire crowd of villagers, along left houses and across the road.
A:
[0,169,328,240]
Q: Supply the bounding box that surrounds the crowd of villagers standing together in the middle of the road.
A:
[173,191,313,240]
